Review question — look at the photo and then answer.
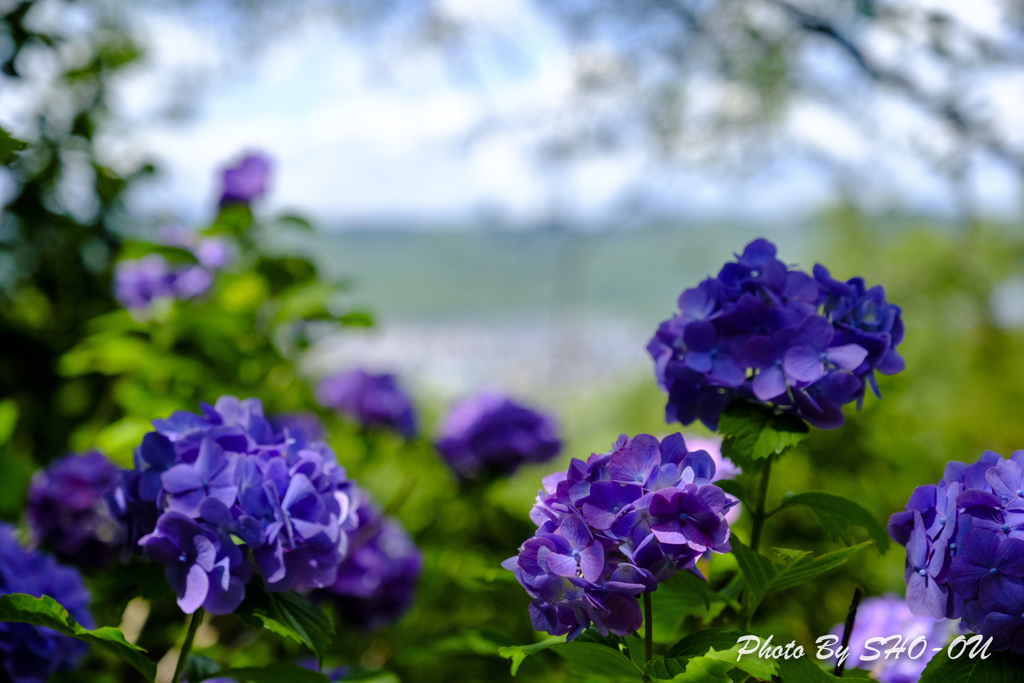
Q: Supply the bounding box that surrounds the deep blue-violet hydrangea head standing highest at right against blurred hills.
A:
[647,240,903,429]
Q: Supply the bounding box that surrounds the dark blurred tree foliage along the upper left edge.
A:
[0,2,154,474]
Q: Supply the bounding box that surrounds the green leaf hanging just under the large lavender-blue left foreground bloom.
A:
[236,582,334,663]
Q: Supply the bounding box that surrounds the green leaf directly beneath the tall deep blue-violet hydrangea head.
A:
[718,403,810,467]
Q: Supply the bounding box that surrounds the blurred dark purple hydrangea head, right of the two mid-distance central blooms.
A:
[435,390,562,481]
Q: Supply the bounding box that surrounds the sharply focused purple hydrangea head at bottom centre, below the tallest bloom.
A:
[502,434,737,640]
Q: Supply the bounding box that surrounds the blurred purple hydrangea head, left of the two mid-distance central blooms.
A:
[316,369,416,438]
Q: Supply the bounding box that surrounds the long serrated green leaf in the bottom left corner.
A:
[0,593,157,681]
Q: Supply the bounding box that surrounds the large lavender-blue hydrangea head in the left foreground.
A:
[116,396,354,614]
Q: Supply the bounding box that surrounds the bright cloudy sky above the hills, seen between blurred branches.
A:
[6,0,1024,229]
